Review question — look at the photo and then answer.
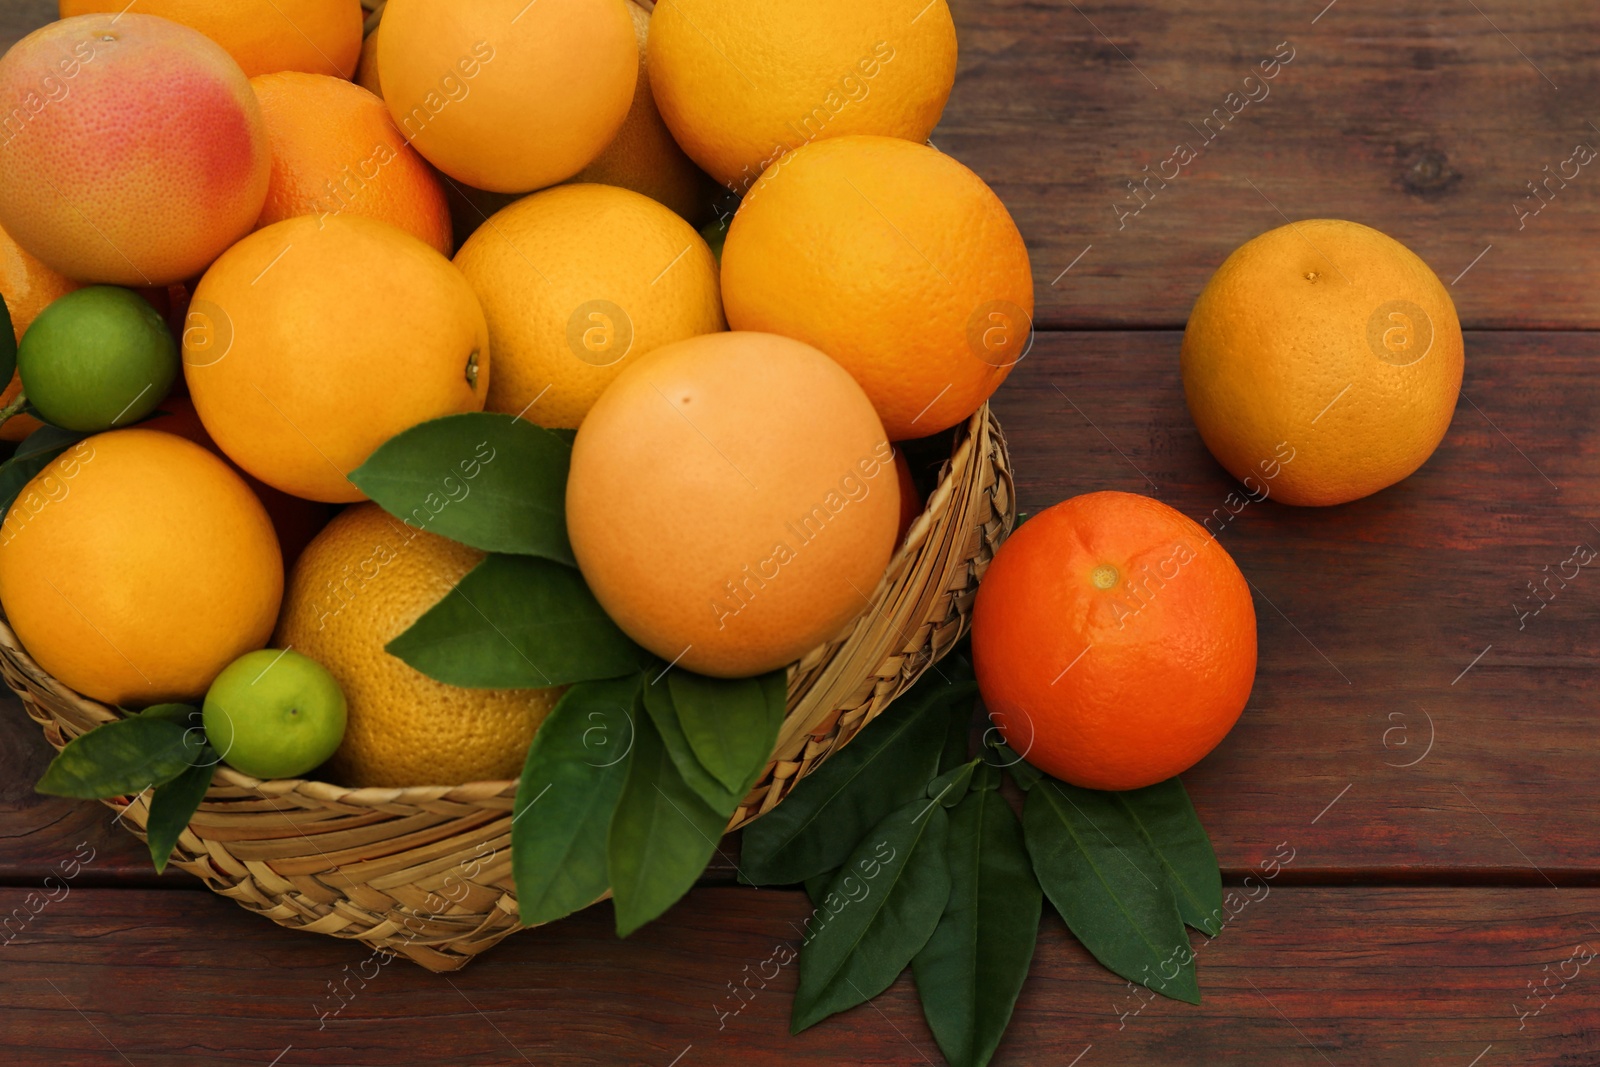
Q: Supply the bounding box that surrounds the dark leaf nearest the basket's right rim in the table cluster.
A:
[739,672,978,885]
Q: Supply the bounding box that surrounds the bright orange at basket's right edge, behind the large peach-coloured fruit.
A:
[722,136,1034,442]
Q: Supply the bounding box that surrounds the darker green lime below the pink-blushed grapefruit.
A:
[16,285,181,434]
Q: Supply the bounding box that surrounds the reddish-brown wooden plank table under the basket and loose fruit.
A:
[0,0,1600,1067]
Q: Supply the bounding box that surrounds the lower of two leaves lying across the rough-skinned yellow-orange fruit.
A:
[386,555,650,689]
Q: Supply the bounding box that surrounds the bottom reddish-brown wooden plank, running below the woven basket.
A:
[0,885,1600,1067]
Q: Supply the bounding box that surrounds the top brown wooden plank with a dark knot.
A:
[933,0,1600,328]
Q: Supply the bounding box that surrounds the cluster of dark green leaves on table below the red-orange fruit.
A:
[741,657,1222,1065]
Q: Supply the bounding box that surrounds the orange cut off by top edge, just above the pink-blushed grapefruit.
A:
[61,0,362,78]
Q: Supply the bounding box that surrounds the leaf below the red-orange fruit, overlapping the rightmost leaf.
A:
[1022,777,1200,1005]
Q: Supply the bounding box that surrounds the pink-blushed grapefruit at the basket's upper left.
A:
[0,13,269,286]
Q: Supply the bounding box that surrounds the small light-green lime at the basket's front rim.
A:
[203,648,346,777]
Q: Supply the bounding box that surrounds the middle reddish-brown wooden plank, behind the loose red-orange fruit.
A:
[0,333,1600,885]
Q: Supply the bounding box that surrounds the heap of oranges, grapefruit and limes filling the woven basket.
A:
[0,0,1034,803]
